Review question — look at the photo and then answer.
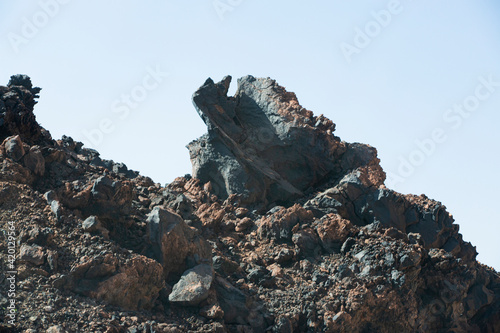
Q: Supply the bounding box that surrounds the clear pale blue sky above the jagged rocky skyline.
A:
[0,0,500,269]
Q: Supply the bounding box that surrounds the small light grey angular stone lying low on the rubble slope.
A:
[168,264,214,306]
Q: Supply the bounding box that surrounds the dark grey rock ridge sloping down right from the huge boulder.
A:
[305,168,476,260]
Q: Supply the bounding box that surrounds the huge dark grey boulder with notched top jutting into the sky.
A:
[188,76,385,206]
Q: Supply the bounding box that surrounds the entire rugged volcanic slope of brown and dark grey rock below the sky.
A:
[0,76,500,332]
